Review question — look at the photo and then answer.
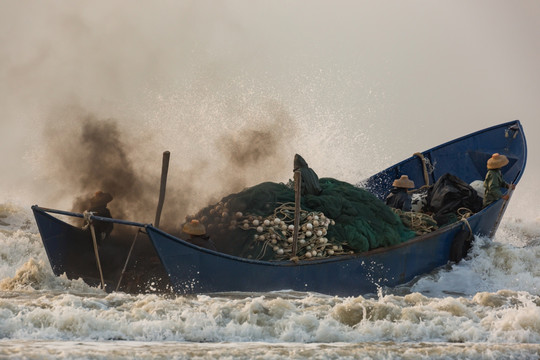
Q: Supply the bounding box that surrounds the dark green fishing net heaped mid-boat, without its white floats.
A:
[188,178,414,259]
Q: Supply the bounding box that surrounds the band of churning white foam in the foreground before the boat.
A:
[0,290,540,343]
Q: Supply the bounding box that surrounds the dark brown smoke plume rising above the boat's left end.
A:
[42,109,178,231]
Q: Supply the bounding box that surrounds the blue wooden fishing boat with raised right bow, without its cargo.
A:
[33,120,527,296]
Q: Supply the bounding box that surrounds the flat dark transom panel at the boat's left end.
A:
[32,206,170,293]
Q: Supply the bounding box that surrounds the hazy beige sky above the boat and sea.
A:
[0,0,540,218]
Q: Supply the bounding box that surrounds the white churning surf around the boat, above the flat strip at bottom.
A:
[0,195,540,350]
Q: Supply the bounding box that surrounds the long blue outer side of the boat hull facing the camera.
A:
[147,197,502,296]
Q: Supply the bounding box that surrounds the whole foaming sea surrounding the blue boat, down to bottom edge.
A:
[0,203,540,359]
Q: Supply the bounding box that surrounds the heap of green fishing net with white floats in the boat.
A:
[187,178,415,260]
